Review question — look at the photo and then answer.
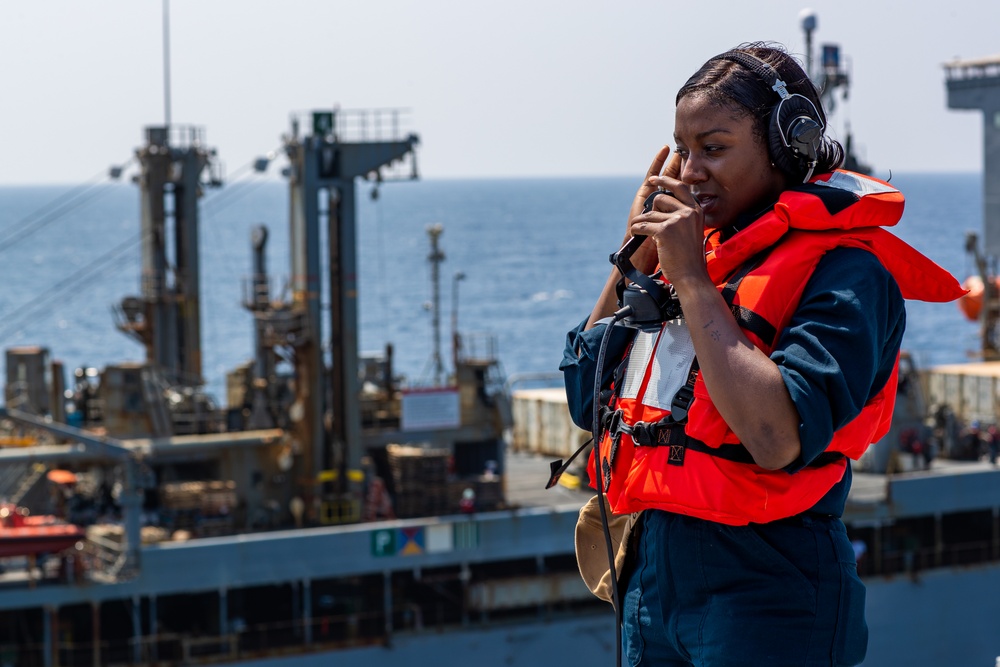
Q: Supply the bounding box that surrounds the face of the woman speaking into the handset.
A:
[674,93,785,227]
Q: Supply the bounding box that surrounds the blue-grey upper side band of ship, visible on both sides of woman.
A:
[0,452,1000,609]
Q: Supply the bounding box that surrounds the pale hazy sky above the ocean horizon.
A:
[0,0,1000,184]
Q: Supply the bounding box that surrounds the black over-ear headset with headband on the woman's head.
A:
[714,51,826,183]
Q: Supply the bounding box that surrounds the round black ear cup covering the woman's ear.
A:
[768,95,824,177]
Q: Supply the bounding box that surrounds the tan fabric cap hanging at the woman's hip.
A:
[575,495,640,602]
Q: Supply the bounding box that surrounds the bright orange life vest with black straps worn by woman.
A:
[591,170,963,525]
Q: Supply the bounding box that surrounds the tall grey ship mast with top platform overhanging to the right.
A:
[284,110,419,506]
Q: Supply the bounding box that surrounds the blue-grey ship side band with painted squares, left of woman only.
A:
[0,454,591,609]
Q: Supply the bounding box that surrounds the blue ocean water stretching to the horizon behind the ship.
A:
[0,173,982,403]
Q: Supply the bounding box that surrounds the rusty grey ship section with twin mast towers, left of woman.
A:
[0,110,572,665]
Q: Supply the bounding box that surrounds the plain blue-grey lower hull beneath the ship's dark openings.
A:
[232,564,1000,667]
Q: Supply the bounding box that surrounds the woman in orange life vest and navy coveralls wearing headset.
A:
[562,44,961,667]
